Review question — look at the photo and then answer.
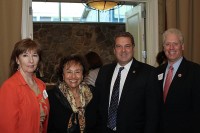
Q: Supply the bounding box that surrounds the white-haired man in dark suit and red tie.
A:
[157,29,200,133]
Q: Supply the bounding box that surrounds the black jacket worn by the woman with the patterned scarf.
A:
[47,86,93,133]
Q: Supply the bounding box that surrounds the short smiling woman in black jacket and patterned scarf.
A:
[48,55,93,133]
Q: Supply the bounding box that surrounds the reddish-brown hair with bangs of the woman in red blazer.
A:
[10,38,42,75]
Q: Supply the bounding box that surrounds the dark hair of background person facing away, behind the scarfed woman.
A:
[85,51,103,69]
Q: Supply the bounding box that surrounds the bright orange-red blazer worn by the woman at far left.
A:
[0,71,49,133]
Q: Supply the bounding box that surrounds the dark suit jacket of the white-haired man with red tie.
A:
[157,58,200,133]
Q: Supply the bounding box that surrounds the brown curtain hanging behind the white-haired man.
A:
[165,0,200,64]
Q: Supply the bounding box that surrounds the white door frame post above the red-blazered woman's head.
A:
[21,0,33,39]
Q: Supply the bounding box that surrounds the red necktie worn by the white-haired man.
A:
[163,66,174,102]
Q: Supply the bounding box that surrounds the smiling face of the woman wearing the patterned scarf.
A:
[63,61,83,89]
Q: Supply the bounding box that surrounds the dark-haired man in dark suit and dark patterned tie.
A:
[90,32,160,133]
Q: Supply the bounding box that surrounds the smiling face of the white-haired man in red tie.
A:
[163,34,184,63]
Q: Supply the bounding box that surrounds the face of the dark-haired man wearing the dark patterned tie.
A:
[114,37,134,66]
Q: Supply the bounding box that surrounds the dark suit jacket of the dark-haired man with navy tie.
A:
[92,59,160,133]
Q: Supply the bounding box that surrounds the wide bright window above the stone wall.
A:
[32,2,133,23]
